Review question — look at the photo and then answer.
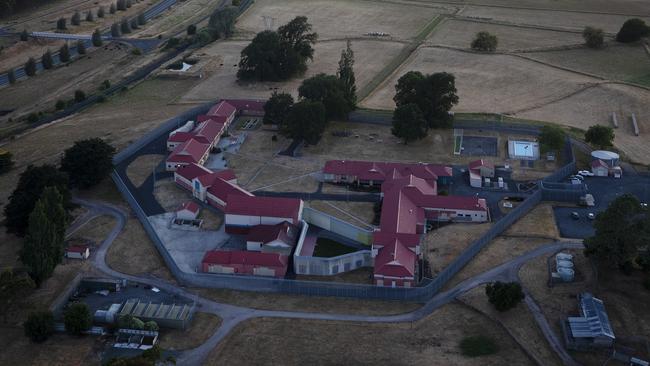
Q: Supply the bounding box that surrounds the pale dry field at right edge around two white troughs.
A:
[517,83,650,165]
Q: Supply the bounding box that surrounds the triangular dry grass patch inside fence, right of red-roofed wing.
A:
[422,223,492,275]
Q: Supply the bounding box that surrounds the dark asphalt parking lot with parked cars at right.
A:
[553,176,650,239]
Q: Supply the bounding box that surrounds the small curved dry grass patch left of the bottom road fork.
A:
[158,312,221,350]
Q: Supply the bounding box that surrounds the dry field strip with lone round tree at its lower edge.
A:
[427,19,584,51]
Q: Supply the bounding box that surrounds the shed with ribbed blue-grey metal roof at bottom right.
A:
[565,292,616,349]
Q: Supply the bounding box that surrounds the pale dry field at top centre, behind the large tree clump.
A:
[237,0,454,39]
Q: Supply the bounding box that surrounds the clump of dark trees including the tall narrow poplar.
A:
[264,41,357,144]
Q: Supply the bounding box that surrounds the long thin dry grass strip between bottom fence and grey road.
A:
[193,288,421,315]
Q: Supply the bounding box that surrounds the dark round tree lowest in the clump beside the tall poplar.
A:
[280,100,327,145]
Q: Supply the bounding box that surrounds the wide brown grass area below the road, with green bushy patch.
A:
[206,304,531,365]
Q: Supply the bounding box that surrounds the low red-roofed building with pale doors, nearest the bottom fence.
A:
[201,250,289,278]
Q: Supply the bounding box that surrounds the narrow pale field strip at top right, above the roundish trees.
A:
[460,6,649,33]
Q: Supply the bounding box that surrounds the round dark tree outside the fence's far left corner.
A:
[61,138,115,189]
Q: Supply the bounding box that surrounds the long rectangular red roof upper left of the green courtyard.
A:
[226,195,302,222]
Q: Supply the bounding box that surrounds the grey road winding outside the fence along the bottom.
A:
[69,198,583,365]
